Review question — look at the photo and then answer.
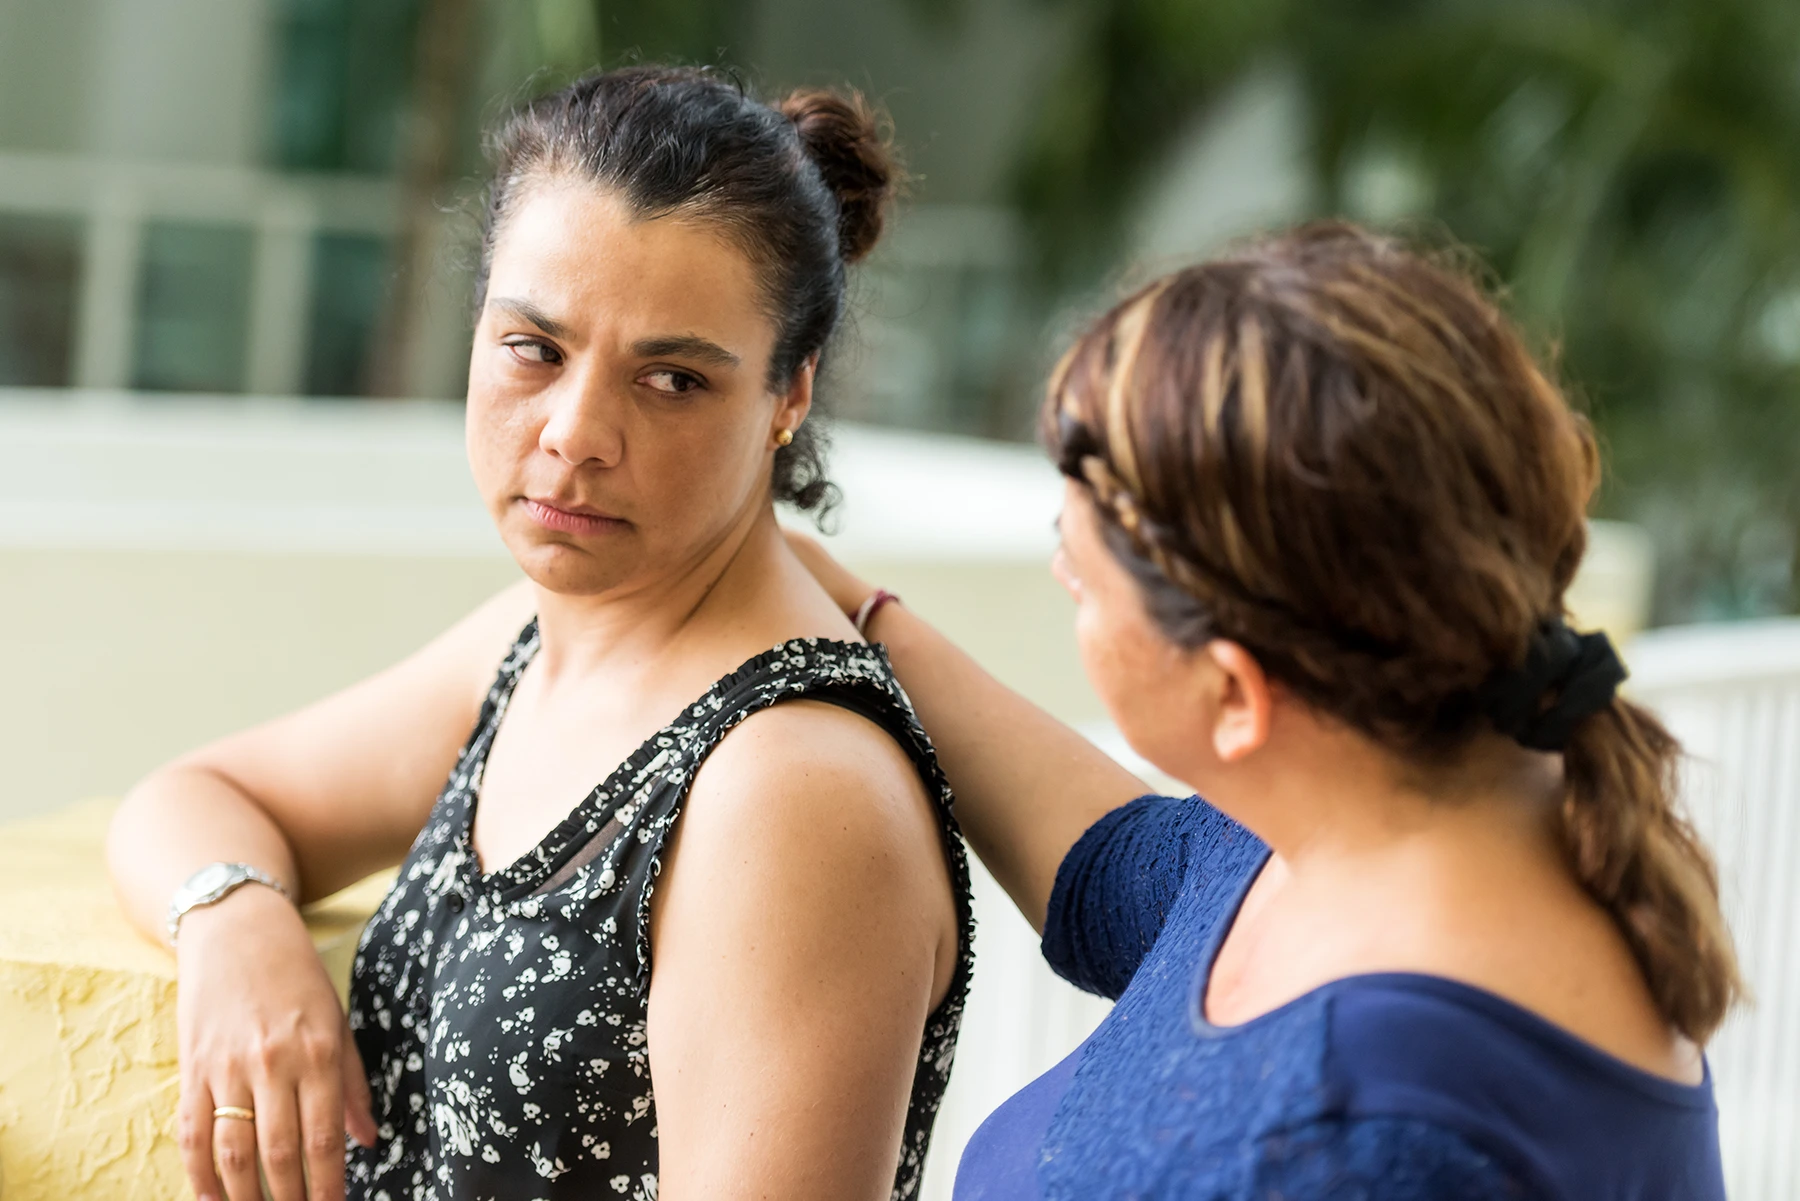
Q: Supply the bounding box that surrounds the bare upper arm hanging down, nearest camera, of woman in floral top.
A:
[650,702,958,1201]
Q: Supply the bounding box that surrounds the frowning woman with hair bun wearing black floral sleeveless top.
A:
[110,67,970,1201]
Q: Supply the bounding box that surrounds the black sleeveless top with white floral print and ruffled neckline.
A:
[346,623,974,1201]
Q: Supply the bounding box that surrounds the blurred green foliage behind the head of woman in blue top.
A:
[1017,0,1800,619]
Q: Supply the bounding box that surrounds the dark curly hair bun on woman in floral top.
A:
[776,88,900,263]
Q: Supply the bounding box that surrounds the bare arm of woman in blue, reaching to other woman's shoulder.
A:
[788,533,1145,931]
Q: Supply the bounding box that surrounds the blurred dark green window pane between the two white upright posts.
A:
[131,221,252,393]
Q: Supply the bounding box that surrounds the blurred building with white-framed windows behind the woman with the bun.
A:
[0,0,1080,436]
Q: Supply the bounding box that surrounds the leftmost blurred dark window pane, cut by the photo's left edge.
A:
[0,214,81,387]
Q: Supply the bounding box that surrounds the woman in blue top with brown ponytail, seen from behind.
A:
[792,225,1741,1201]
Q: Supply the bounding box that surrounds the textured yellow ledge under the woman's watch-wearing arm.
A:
[0,803,387,1201]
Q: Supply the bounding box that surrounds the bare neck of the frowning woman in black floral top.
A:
[536,504,783,679]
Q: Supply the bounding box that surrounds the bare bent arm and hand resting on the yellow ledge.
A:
[106,576,531,1201]
